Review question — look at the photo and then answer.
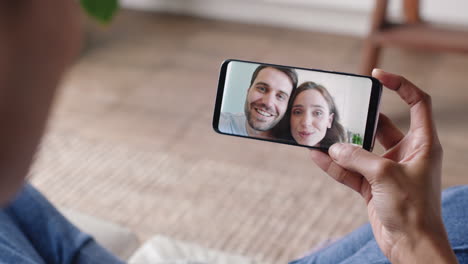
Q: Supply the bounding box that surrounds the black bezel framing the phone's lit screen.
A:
[212,59,382,151]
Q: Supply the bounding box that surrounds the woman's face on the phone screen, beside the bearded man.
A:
[291,90,333,146]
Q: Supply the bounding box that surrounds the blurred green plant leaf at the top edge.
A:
[80,0,119,23]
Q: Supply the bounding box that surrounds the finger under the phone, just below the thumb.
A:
[310,150,363,194]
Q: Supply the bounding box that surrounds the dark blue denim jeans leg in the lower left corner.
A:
[0,184,123,264]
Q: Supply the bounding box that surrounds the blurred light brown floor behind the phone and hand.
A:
[31,11,468,263]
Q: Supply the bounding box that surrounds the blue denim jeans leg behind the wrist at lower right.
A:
[290,186,468,264]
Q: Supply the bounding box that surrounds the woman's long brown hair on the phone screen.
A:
[273,82,346,148]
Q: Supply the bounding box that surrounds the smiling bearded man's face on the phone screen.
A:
[244,67,293,131]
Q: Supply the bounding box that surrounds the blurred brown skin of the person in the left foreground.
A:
[0,0,79,204]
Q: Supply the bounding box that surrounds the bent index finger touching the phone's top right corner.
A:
[372,69,435,132]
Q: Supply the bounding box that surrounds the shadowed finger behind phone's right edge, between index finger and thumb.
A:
[376,113,405,150]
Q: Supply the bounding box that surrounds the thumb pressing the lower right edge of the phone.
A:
[328,143,396,184]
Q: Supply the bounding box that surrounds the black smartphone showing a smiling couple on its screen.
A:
[213,59,382,151]
